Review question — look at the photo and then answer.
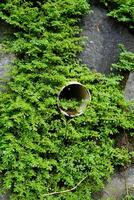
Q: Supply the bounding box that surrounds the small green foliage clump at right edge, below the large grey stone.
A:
[112,45,134,72]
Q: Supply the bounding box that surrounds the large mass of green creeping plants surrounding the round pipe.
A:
[0,0,134,200]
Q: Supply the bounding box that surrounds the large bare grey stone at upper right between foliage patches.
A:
[80,3,134,74]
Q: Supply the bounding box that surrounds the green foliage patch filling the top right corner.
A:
[101,0,134,29]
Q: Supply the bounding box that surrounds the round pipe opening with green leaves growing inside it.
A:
[58,82,90,117]
